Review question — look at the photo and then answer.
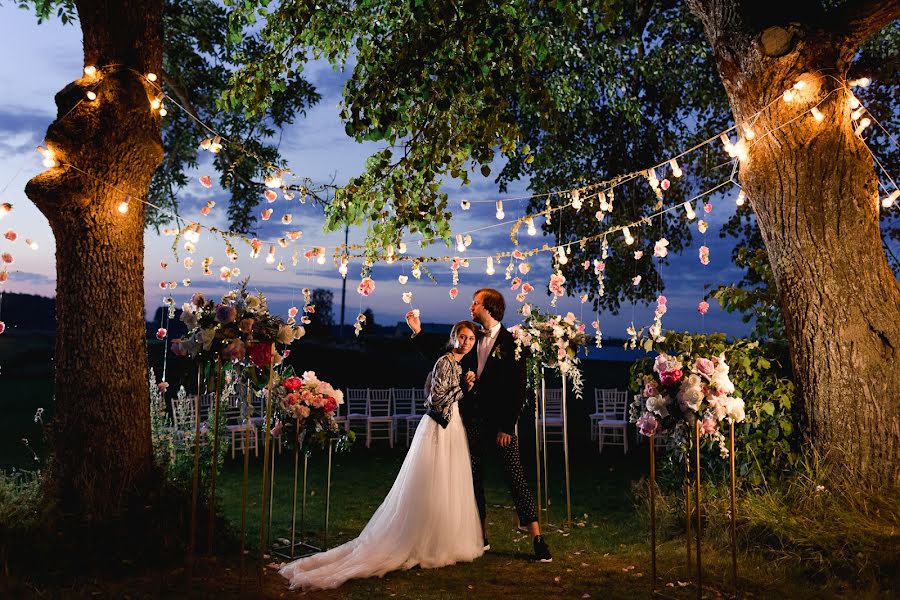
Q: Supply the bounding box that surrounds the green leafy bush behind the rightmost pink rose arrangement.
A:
[631,332,801,486]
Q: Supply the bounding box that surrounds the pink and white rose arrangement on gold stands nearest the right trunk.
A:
[630,352,745,457]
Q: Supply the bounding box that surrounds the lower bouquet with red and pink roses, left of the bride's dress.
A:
[272,367,355,451]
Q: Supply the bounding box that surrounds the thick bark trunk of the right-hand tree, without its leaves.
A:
[691,0,900,487]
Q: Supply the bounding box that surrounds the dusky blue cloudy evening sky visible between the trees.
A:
[0,4,748,338]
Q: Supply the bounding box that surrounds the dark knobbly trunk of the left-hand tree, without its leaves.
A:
[25,0,162,522]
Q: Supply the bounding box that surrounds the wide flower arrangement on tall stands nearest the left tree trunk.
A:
[171,280,306,369]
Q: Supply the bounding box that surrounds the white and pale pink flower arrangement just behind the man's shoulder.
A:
[510,303,588,399]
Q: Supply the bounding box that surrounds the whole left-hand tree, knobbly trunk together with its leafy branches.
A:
[19,0,318,522]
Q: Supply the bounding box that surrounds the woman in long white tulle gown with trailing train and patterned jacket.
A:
[278,321,484,589]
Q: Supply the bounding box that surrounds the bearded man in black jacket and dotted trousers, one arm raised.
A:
[406,288,553,562]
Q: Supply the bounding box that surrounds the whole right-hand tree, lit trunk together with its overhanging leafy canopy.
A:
[228,0,900,485]
